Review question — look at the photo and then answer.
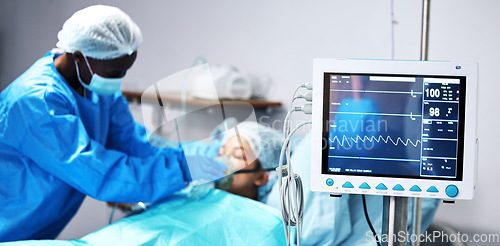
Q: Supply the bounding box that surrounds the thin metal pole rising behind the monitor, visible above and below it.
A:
[412,0,431,246]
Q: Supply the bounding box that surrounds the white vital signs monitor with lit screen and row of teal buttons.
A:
[311,59,478,200]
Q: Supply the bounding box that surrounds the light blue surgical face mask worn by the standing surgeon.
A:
[75,56,123,96]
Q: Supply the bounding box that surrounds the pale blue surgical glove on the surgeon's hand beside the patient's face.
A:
[186,154,226,182]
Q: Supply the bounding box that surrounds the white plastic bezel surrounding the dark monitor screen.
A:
[311,59,478,199]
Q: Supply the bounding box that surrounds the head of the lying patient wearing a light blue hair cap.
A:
[219,122,282,200]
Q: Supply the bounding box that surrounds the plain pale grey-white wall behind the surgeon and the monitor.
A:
[0,0,500,238]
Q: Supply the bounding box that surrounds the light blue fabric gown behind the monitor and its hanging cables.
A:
[267,134,440,246]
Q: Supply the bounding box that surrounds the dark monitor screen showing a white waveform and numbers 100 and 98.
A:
[322,72,466,180]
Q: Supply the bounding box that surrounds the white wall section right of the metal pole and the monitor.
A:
[422,0,500,233]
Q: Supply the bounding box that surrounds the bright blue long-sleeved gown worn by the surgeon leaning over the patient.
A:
[0,52,190,241]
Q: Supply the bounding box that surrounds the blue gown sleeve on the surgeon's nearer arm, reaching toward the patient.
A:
[14,91,185,202]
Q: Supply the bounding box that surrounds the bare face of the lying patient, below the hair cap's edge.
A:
[219,136,268,199]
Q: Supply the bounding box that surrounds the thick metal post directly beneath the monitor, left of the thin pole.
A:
[381,196,408,246]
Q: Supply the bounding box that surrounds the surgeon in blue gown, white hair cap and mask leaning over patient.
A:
[0,5,226,242]
